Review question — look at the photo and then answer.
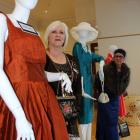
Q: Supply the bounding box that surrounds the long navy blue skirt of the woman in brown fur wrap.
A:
[96,97,119,140]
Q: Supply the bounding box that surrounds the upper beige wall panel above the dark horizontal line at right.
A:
[95,0,140,37]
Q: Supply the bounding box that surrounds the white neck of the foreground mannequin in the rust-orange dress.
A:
[8,3,30,23]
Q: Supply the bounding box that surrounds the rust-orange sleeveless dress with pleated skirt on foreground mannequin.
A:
[0,13,68,140]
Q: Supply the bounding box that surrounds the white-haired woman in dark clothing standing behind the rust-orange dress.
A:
[45,21,82,140]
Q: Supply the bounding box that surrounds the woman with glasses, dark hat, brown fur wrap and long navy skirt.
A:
[95,49,130,140]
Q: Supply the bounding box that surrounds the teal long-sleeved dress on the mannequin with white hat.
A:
[73,42,103,124]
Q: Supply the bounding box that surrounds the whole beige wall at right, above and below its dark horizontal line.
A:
[95,0,140,95]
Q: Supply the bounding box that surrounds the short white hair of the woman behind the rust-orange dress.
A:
[44,20,69,47]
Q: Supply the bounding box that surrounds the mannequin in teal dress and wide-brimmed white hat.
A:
[71,22,103,140]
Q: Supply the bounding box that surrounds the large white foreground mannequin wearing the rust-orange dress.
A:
[0,0,72,140]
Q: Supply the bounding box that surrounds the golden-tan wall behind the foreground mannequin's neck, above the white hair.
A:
[0,0,75,30]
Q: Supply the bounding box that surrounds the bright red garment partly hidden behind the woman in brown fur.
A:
[105,53,126,118]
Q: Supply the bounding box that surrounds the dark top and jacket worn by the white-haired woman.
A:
[45,54,82,111]
